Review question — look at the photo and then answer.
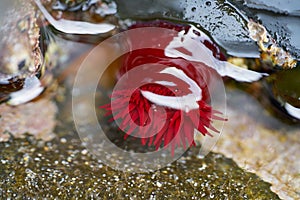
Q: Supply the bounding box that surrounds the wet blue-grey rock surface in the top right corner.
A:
[233,0,300,60]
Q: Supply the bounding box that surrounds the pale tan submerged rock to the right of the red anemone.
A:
[213,90,300,199]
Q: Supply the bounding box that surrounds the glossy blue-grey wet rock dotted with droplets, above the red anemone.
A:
[116,0,259,57]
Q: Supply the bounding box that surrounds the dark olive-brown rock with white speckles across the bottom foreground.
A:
[0,136,279,199]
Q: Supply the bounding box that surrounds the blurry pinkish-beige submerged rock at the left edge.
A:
[0,99,57,142]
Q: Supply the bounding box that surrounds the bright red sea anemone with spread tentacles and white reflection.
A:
[102,22,224,153]
